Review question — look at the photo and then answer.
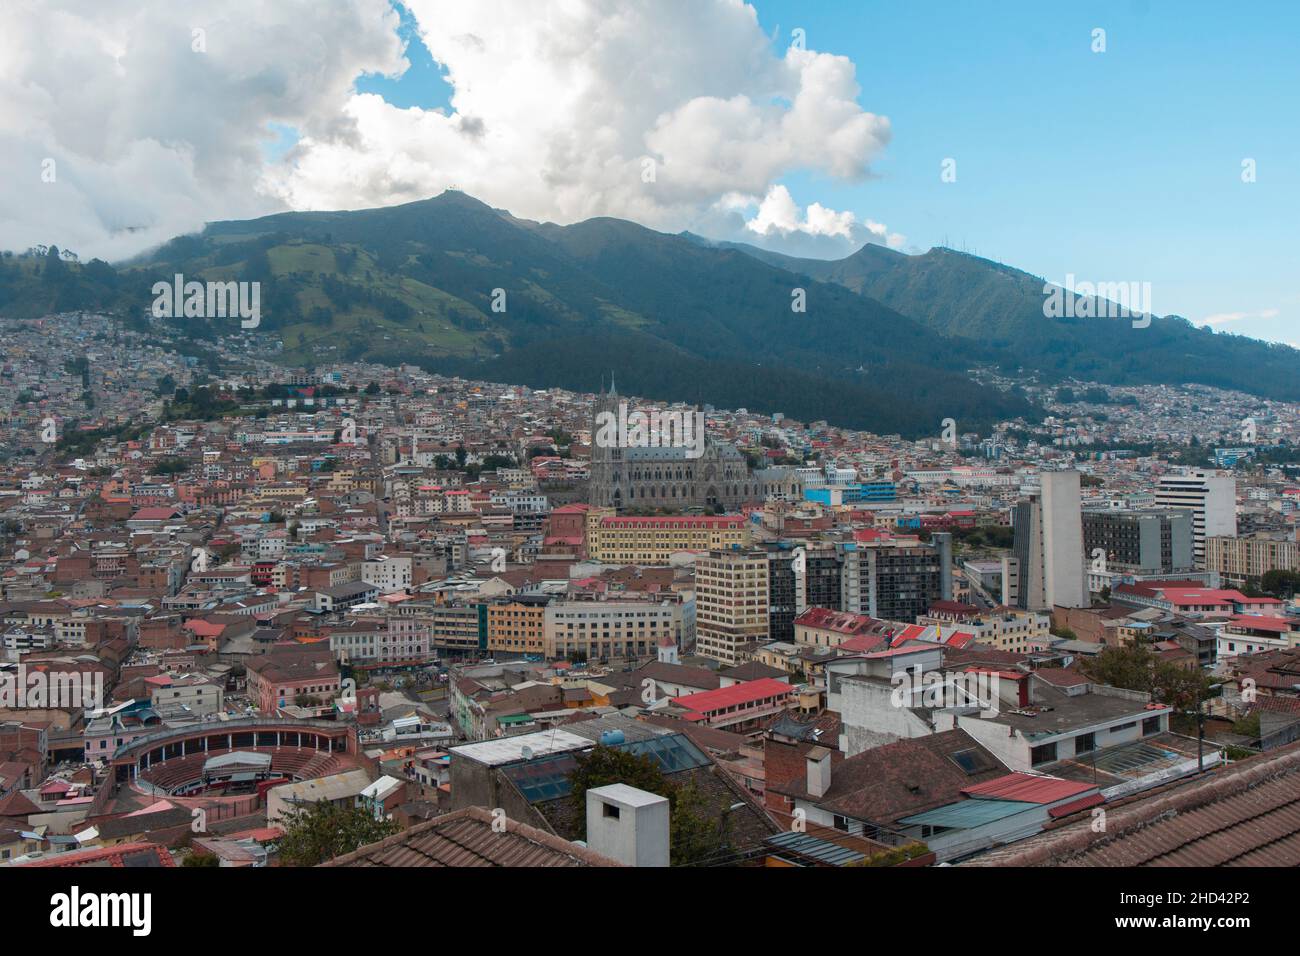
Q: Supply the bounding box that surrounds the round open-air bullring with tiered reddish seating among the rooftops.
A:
[111,718,361,805]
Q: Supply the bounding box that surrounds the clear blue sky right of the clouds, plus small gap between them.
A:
[340,0,1300,343]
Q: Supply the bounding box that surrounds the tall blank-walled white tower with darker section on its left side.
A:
[1004,471,1091,610]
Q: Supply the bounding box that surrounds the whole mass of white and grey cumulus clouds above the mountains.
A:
[0,0,901,256]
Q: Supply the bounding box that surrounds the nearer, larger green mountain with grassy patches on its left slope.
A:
[0,193,1037,436]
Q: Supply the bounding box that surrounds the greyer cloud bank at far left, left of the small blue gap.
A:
[0,0,404,258]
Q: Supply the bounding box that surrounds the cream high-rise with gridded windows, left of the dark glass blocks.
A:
[696,551,768,665]
